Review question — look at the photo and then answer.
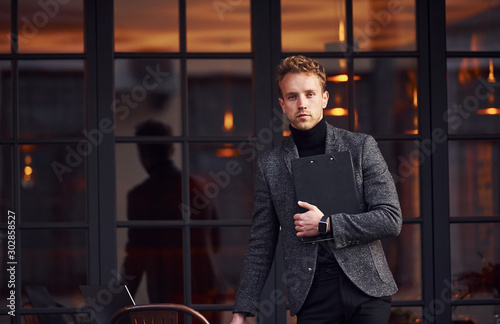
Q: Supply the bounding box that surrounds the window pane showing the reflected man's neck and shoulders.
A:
[115,142,183,221]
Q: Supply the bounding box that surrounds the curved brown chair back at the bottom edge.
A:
[109,304,210,324]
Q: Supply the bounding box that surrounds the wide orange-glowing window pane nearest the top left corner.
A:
[18,0,84,53]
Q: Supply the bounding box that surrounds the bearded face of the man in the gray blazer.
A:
[279,72,328,130]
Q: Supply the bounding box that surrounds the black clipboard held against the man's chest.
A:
[291,151,360,243]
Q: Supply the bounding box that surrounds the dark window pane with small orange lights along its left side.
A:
[19,141,87,222]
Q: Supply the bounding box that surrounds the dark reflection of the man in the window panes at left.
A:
[123,121,219,320]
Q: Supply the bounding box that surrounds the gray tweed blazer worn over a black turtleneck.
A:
[233,125,402,316]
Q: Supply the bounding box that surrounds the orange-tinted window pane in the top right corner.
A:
[446,0,500,51]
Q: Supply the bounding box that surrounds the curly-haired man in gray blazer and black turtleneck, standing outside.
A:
[231,56,402,324]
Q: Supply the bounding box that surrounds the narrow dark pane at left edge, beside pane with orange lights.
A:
[0,145,15,224]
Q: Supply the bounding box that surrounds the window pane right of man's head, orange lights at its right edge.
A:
[354,58,418,134]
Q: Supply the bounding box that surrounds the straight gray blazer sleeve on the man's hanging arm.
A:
[233,154,279,316]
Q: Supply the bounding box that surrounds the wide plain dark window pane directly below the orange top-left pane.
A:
[19,60,85,138]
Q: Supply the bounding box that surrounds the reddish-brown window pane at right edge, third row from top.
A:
[448,141,500,217]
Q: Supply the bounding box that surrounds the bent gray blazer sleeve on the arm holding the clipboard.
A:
[330,135,402,248]
